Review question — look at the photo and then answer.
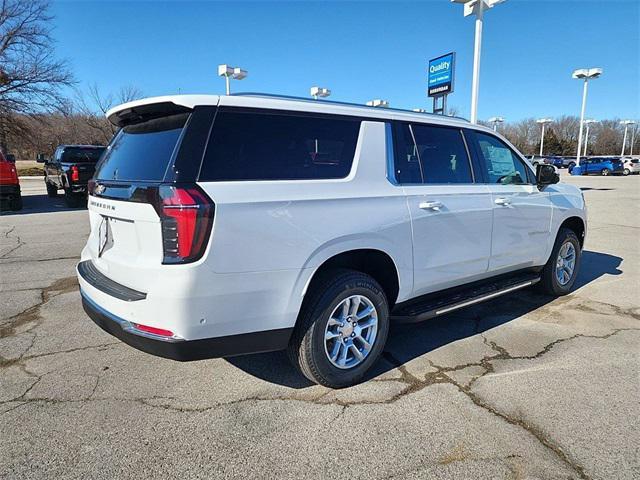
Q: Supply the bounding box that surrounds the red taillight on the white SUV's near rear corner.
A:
[156,185,214,263]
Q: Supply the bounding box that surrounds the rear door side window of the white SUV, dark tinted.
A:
[411,125,473,183]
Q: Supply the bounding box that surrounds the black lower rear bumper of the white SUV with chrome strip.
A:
[80,290,293,362]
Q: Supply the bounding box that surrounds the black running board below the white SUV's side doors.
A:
[391,273,540,323]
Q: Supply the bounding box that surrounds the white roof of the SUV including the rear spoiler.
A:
[106,93,471,126]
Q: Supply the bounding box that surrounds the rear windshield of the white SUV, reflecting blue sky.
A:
[95,113,189,182]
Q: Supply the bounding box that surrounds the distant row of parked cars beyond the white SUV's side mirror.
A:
[527,155,640,176]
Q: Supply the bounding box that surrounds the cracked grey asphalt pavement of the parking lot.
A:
[0,174,640,479]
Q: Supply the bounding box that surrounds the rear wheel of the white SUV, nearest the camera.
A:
[288,269,389,388]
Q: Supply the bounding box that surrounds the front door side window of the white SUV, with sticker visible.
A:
[475,132,529,185]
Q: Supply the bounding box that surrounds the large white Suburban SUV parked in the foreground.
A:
[78,94,586,387]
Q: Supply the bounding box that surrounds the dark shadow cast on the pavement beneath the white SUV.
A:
[227,251,622,389]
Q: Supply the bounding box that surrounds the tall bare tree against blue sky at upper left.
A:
[0,0,73,150]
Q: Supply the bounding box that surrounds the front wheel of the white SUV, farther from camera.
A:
[539,228,582,296]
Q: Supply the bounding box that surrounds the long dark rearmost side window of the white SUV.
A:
[200,111,360,181]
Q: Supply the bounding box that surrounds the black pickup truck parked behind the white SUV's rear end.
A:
[38,145,106,207]
